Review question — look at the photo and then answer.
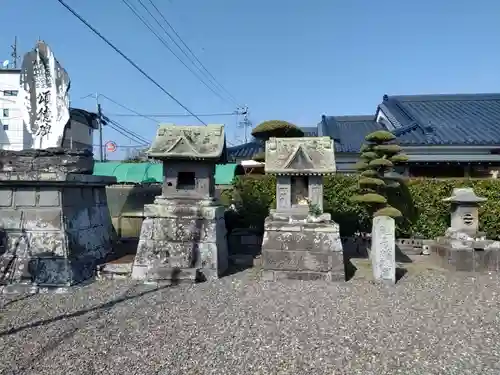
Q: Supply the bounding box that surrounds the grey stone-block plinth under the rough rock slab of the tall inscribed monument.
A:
[0,175,114,286]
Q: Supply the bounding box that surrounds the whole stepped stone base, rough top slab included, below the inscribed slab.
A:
[0,148,116,293]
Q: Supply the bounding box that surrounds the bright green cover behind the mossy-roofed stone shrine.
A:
[93,161,237,185]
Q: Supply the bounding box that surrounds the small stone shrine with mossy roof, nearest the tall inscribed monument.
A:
[132,125,228,282]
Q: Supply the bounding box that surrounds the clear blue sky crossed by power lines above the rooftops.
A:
[0,0,500,158]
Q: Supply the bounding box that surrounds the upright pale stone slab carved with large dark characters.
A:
[18,41,70,149]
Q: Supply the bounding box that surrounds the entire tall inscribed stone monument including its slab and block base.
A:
[0,42,116,293]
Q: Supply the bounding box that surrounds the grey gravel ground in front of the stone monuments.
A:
[0,270,500,375]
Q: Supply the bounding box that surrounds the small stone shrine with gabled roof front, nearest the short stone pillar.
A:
[262,137,345,281]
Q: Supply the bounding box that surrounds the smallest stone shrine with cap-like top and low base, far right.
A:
[430,188,500,272]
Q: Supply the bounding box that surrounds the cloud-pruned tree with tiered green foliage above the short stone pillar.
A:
[353,130,408,217]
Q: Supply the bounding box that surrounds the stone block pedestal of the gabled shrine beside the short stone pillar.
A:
[262,217,345,281]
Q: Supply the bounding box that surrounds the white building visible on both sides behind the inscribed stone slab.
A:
[0,69,98,150]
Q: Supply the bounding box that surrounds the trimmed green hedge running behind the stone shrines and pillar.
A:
[223,175,500,239]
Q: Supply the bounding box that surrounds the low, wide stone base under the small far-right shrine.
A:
[429,237,500,272]
